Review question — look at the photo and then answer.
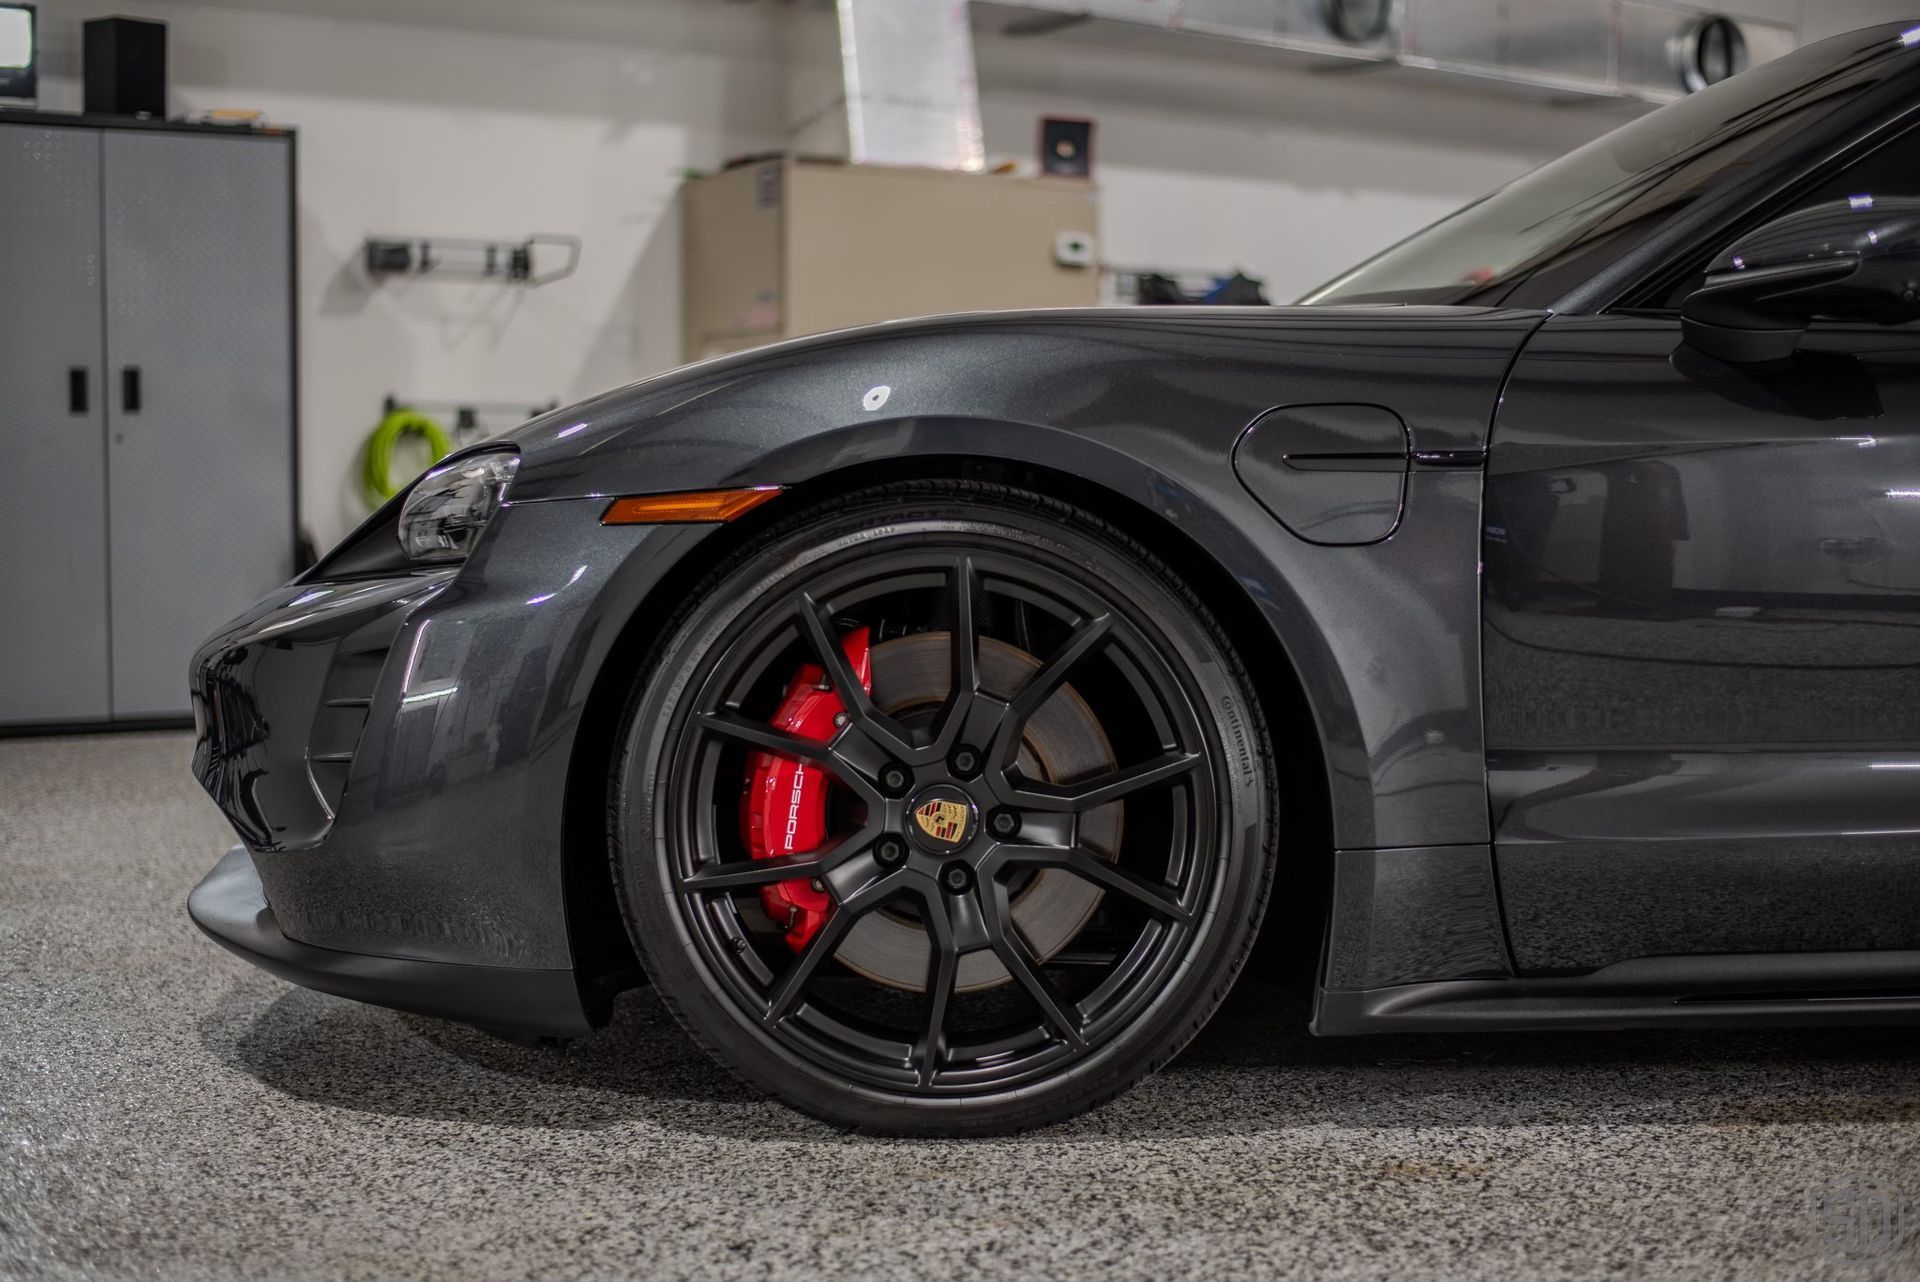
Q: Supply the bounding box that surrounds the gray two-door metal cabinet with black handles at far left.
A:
[0,115,296,725]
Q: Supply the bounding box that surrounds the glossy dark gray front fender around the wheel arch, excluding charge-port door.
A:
[513,307,1540,848]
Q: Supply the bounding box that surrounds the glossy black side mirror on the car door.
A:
[1680,196,1920,365]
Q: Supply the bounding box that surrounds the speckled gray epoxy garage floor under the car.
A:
[0,735,1920,1280]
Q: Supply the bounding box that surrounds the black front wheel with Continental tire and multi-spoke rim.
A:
[609,482,1275,1136]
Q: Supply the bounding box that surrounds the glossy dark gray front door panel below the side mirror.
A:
[1486,317,1920,973]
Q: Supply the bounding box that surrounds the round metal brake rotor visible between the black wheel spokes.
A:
[833,631,1123,992]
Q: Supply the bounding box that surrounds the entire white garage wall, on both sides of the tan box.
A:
[40,0,1920,547]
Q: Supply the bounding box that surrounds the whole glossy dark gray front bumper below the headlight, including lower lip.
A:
[190,501,707,1031]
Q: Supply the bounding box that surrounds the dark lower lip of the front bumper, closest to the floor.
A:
[186,846,591,1038]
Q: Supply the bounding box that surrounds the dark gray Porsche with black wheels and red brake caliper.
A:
[190,27,1920,1134]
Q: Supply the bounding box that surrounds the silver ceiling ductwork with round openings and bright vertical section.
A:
[783,0,1799,169]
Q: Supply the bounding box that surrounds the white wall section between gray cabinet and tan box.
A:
[40,0,783,547]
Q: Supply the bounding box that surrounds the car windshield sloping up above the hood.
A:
[1300,23,1920,303]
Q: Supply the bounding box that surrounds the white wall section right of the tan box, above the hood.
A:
[975,35,1638,301]
